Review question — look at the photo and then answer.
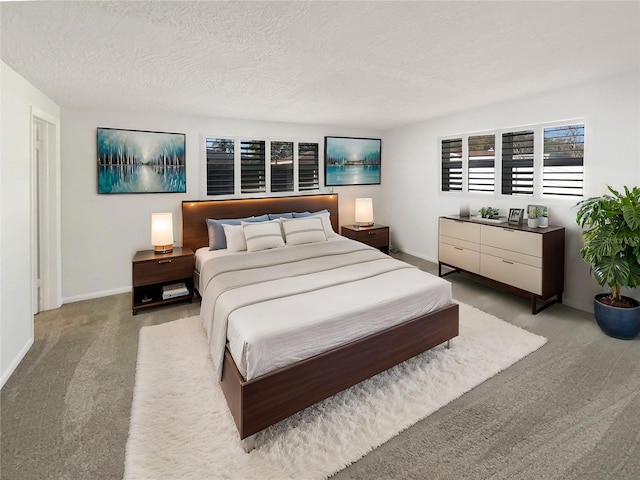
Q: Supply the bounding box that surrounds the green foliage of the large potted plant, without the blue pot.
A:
[576,186,640,302]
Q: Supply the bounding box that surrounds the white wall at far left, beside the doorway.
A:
[0,62,60,385]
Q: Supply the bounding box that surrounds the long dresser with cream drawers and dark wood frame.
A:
[438,215,565,314]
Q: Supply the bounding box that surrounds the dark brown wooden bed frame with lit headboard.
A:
[182,194,458,451]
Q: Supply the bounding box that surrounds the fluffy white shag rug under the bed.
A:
[124,304,547,480]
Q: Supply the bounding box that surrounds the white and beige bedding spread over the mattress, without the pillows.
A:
[201,239,452,380]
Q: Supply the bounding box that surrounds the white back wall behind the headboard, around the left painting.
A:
[61,108,386,303]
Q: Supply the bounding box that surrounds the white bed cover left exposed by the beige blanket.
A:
[202,237,452,380]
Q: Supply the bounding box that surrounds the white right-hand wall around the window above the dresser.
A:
[382,71,640,311]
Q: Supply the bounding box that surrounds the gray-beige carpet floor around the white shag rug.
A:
[0,255,640,480]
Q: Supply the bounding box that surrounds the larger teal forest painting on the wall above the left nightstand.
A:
[97,128,187,193]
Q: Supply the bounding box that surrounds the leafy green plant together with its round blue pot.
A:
[576,186,640,339]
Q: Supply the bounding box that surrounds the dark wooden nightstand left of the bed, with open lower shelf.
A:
[131,247,194,315]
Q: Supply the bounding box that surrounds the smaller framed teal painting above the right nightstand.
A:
[324,137,382,187]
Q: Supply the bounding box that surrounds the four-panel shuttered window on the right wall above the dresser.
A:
[441,122,585,198]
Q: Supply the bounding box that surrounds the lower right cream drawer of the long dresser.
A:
[480,253,542,295]
